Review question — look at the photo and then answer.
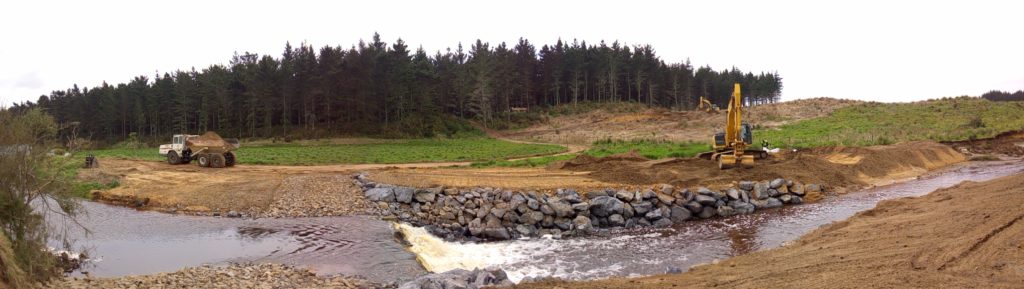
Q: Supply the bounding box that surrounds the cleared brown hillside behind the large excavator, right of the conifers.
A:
[494,98,860,146]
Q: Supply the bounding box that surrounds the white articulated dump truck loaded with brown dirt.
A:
[160,131,239,168]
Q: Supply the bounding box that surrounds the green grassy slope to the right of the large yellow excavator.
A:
[754,97,1024,148]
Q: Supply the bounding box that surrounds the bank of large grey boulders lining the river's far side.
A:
[354,174,822,241]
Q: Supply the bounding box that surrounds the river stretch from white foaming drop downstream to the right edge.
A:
[396,161,1024,282]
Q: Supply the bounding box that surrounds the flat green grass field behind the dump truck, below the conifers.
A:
[86,137,566,165]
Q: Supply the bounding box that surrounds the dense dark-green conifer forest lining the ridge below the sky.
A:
[14,34,782,139]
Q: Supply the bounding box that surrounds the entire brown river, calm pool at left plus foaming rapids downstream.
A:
[54,161,1024,282]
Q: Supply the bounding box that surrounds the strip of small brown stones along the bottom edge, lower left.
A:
[50,263,383,289]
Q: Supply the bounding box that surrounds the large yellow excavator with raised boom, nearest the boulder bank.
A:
[697,83,768,169]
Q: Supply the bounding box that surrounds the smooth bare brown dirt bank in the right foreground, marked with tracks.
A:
[517,167,1024,288]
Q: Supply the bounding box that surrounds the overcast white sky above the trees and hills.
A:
[0,0,1024,104]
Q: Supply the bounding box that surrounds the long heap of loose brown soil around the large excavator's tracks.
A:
[562,141,965,187]
